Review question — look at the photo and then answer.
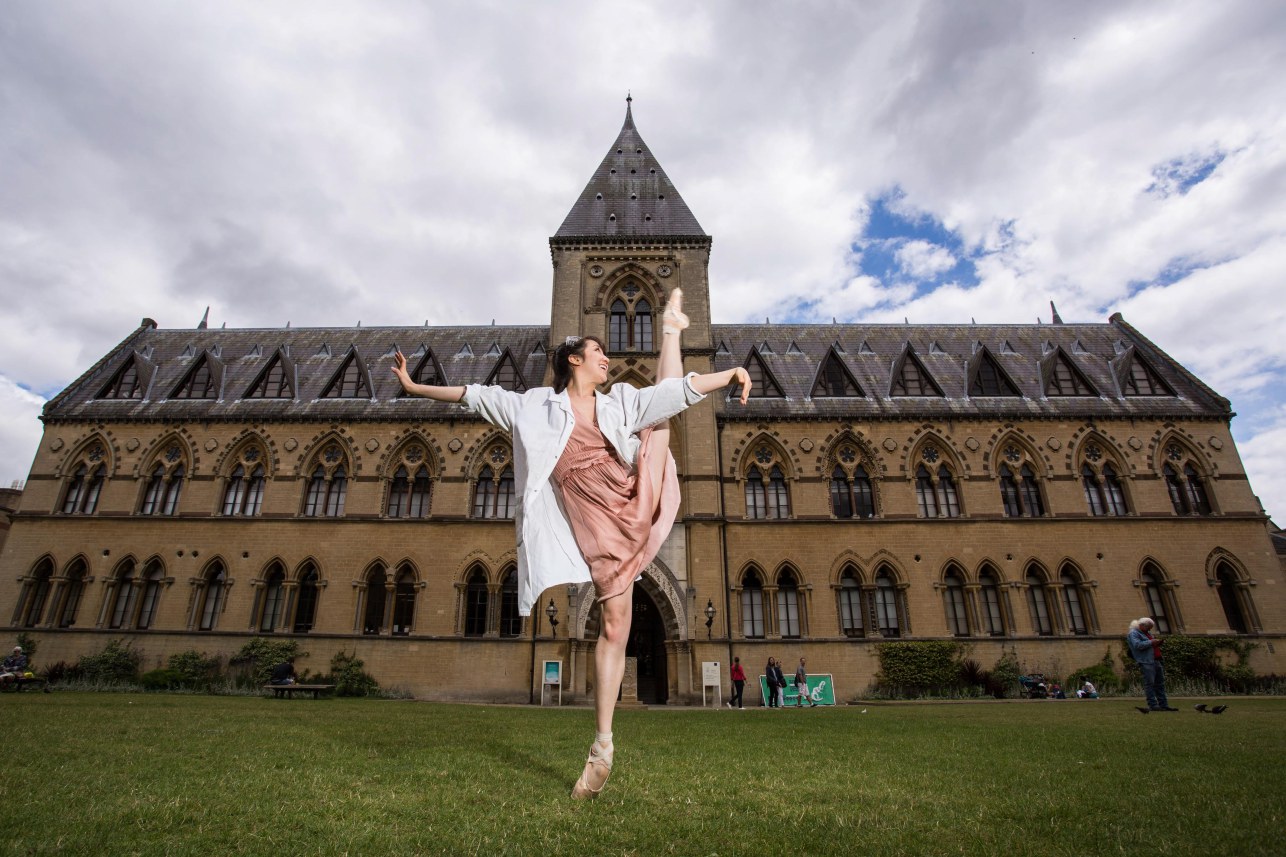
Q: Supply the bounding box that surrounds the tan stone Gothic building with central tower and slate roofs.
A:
[0,103,1286,703]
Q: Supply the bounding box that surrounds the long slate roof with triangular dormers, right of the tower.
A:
[711,315,1232,419]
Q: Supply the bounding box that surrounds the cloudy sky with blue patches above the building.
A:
[0,0,1286,520]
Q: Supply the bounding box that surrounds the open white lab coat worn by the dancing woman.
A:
[460,372,705,616]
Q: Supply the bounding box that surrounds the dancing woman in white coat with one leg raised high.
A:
[392,288,750,799]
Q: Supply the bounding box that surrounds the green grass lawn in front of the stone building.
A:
[0,692,1286,857]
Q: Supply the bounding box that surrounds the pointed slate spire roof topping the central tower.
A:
[553,100,707,241]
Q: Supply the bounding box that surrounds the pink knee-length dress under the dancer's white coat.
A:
[553,419,679,601]
